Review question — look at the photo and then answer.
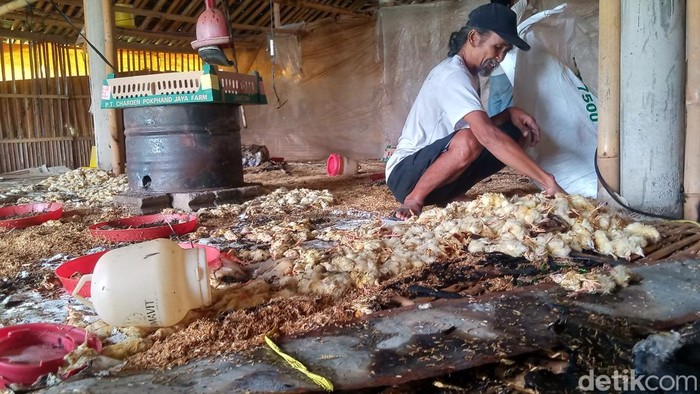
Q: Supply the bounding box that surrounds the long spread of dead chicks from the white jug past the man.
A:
[204,189,659,309]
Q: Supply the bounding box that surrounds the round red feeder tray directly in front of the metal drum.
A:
[88,213,197,242]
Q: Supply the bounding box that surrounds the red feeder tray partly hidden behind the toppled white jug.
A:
[55,242,222,298]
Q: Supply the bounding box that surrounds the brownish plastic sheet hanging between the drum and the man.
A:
[239,20,385,160]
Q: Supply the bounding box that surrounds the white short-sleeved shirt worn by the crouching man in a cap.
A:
[385,55,486,179]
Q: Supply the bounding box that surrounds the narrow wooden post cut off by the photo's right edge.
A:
[683,0,700,221]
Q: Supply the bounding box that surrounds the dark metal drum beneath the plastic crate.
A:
[124,103,243,193]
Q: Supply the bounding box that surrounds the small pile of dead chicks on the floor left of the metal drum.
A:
[18,168,128,206]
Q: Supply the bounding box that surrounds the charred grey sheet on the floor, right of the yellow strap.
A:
[281,287,559,390]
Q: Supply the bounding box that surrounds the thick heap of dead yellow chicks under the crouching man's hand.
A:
[415,193,660,261]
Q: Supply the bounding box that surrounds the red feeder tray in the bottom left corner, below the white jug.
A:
[0,323,102,387]
